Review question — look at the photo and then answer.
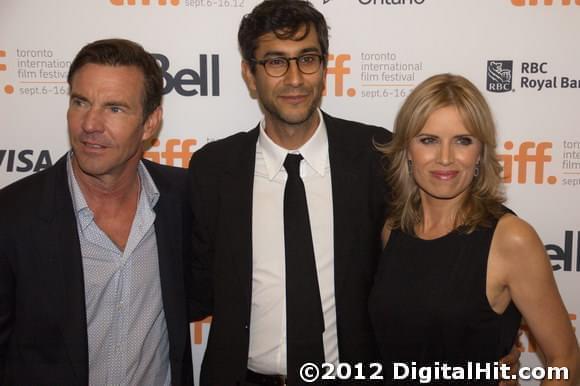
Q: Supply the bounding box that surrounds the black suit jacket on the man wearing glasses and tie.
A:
[189,114,390,386]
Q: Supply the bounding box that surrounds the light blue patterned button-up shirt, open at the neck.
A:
[67,155,171,385]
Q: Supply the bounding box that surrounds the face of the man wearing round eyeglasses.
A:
[242,25,326,136]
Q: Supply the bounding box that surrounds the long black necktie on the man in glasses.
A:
[284,154,324,386]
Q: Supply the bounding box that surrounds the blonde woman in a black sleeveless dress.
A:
[369,74,579,385]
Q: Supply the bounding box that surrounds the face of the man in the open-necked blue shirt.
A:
[67,64,161,184]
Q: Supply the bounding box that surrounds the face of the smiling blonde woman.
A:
[408,102,482,203]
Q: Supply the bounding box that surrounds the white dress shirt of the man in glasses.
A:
[248,111,338,374]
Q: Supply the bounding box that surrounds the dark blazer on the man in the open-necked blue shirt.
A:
[0,156,193,385]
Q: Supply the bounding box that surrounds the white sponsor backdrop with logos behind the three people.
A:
[0,0,580,385]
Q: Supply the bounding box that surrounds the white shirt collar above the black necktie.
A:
[258,110,329,180]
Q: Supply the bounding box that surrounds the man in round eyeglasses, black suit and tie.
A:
[189,0,390,386]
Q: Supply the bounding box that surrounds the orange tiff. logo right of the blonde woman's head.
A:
[499,141,558,185]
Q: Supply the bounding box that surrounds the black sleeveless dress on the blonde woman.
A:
[369,224,521,385]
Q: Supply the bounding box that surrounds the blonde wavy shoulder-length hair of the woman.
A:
[377,74,505,234]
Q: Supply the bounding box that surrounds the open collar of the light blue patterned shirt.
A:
[66,150,160,230]
